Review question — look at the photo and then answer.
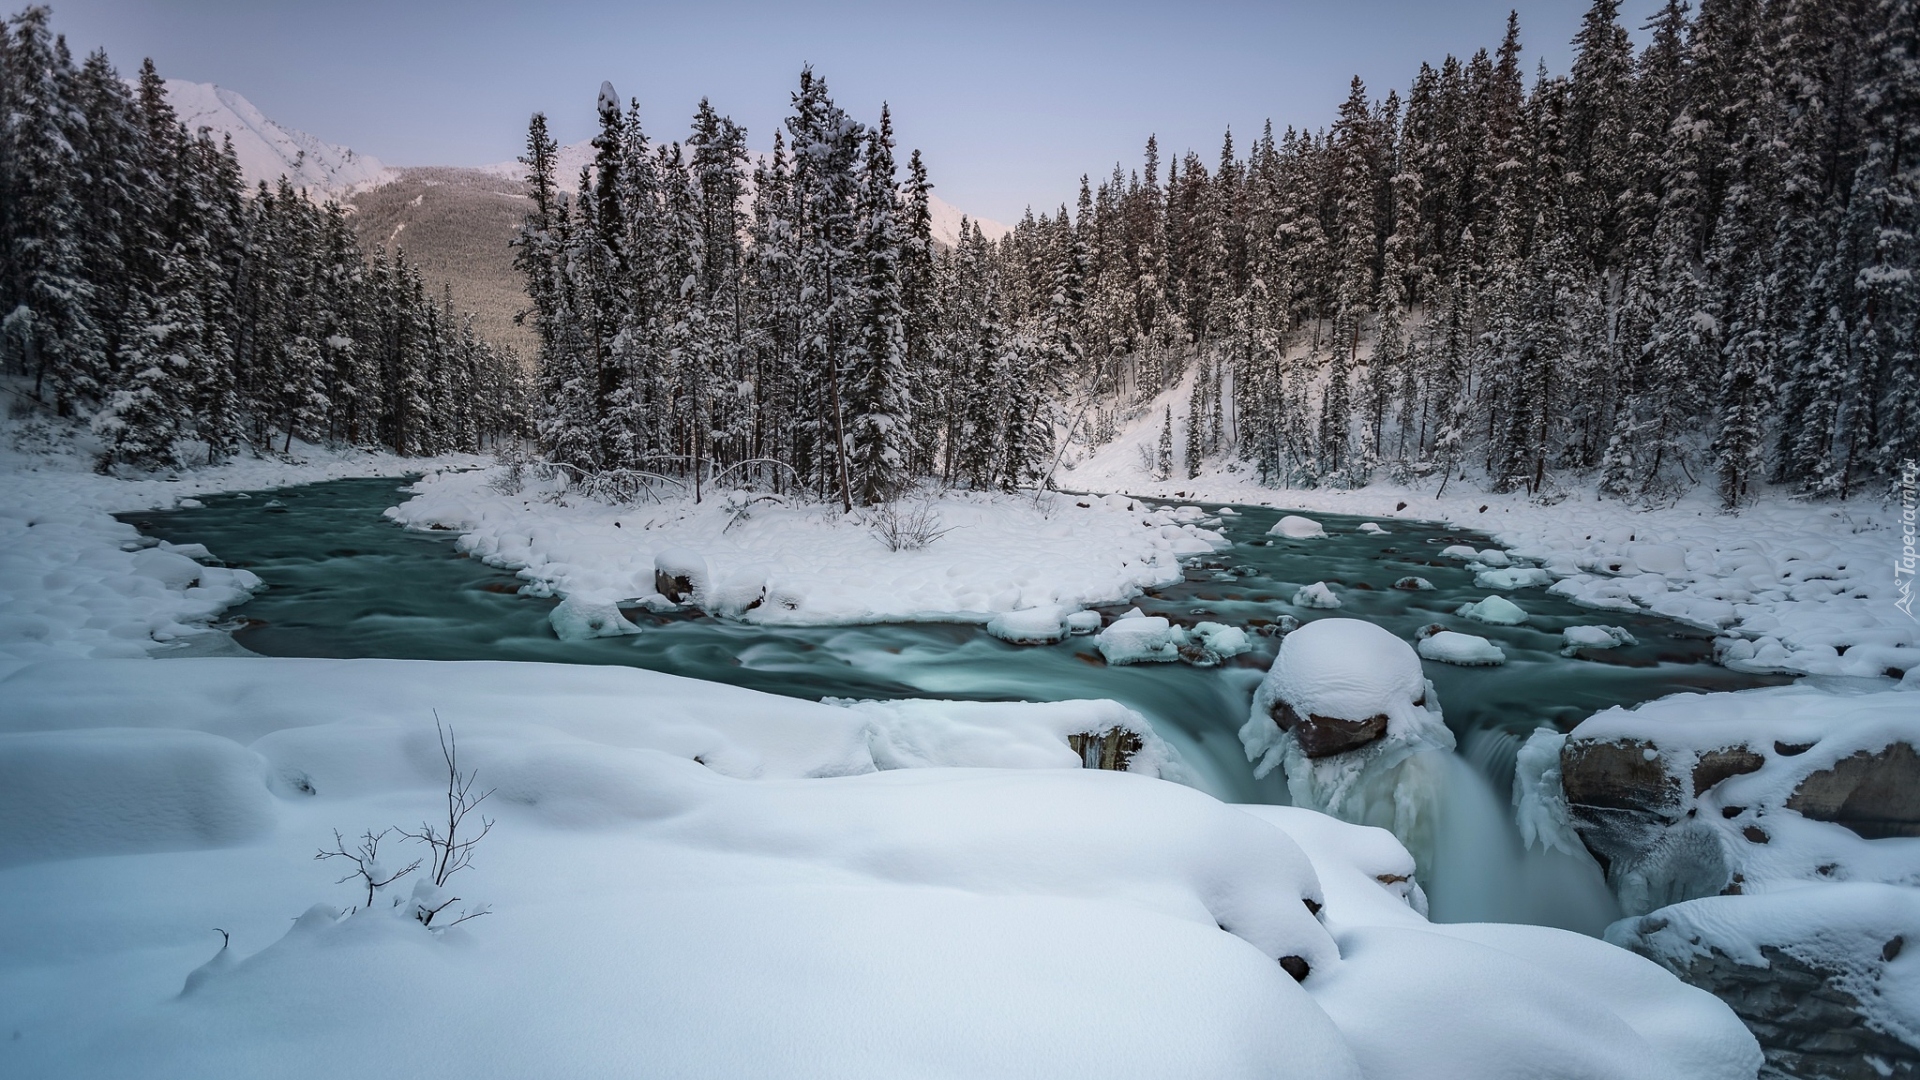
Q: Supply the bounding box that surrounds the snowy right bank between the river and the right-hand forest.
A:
[1058,377,1920,676]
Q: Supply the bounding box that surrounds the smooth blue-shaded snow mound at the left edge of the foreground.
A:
[0,722,275,865]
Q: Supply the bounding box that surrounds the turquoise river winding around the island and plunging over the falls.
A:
[123,479,1780,932]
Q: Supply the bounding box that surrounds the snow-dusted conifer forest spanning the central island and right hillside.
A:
[516,0,1920,507]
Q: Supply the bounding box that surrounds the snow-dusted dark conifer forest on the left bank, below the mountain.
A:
[0,8,528,471]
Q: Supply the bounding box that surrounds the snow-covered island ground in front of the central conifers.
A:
[388,469,1229,626]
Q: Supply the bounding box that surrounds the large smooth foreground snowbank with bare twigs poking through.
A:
[0,653,1757,1080]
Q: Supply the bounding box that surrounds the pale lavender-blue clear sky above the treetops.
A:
[45,0,1659,225]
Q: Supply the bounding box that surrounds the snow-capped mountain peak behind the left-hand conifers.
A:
[167,79,394,196]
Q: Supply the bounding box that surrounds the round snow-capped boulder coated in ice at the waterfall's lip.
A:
[1240,619,1453,867]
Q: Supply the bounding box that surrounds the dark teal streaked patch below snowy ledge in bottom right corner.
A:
[1634,945,1920,1080]
